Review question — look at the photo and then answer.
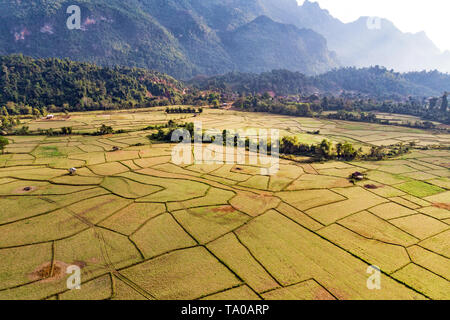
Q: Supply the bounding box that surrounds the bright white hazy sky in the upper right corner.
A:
[297,0,450,50]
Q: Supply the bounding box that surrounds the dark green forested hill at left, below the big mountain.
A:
[0,55,183,113]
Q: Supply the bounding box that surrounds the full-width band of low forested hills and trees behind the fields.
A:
[0,55,450,130]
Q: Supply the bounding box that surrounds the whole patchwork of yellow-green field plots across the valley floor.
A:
[0,110,450,299]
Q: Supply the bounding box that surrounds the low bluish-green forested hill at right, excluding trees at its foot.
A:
[190,66,450,99]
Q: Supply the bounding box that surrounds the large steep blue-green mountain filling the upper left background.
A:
[0,0,338,78]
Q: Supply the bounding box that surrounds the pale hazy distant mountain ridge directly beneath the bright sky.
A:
[261,0,450,72]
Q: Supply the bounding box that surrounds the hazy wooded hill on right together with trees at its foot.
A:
[190,66,450,128]
